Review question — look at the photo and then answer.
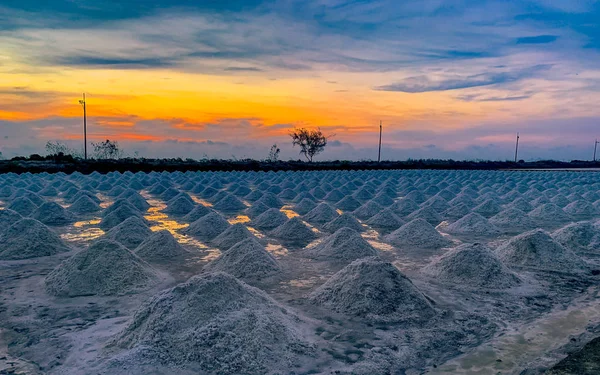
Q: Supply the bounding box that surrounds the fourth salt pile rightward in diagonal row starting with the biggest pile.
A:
[496,229,587,273]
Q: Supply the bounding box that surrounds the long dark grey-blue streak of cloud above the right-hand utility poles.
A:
[374,65,552,93]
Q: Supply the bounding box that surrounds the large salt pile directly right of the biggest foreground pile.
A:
[310,257,435,322]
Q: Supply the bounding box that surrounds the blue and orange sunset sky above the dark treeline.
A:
[0,0,600,160]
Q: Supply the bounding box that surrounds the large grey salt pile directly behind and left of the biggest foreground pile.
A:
[46,240,159,297]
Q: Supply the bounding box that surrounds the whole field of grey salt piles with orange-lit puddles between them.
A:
[0,170,600,375]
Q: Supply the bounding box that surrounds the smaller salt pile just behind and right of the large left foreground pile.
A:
[135,230,189,263]
